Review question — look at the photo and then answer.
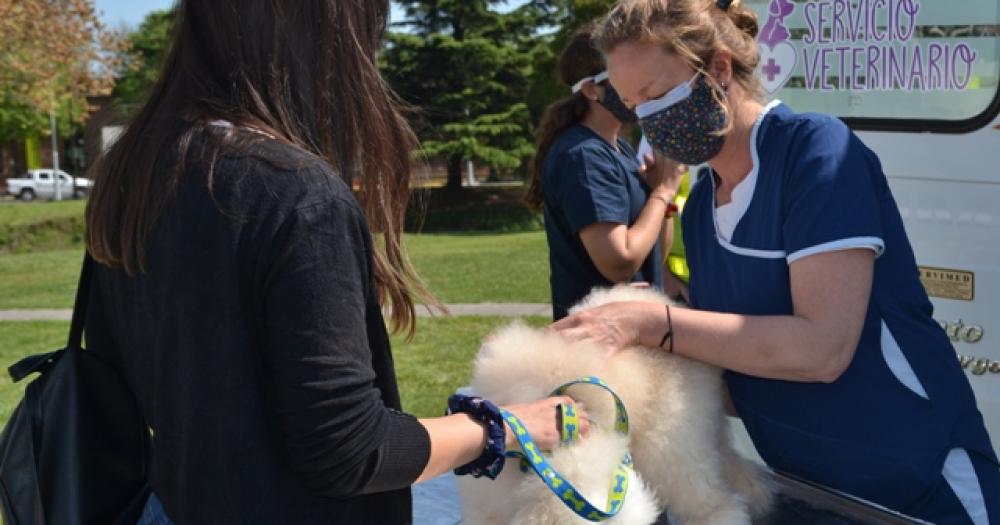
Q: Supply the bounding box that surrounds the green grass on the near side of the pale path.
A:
[0,317,547,425]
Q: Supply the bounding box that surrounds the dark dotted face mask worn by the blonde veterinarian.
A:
[635,73,726,165]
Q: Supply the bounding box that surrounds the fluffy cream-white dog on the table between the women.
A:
[459,286,773,525]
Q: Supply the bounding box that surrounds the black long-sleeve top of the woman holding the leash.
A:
[86,130,430,524]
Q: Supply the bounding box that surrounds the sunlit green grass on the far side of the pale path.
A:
[0,232,549,310]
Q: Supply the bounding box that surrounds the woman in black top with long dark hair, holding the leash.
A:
[86,0,570,524]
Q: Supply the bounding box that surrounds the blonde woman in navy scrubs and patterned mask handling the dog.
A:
[554,0,1000,525]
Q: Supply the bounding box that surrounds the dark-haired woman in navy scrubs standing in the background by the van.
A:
[526,26,677,320]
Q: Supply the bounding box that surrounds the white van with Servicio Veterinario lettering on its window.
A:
[732,0,1000,454]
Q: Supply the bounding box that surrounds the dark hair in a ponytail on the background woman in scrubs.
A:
[524,24,604,211]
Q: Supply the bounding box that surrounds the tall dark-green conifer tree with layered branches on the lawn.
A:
[383,0,545,188]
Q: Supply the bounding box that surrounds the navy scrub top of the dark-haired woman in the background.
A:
[542,125,663,320]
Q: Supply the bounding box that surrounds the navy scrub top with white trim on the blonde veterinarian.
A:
[683,103,997,512]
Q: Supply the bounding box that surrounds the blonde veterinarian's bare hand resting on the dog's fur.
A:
[549,302,663,357]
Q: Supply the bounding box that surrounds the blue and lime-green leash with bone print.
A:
[500,376,633,522]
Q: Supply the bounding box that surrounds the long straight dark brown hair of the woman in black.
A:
[87,0,433,334]
